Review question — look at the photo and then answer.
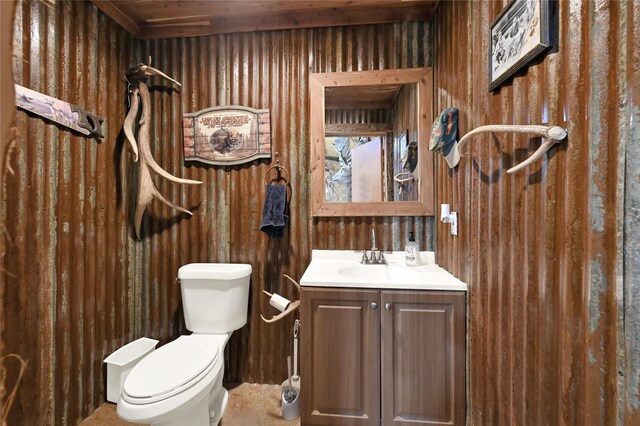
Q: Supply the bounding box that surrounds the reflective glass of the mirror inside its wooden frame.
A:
[325,84,418,202]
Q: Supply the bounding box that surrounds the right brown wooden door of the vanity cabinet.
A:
[381,291,466,426]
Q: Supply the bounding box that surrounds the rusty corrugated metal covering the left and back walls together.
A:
[1,1,433,424]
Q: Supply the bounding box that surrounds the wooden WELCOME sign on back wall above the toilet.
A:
[182,106,271,166]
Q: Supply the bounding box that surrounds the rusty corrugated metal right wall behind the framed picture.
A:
[434,1,640,425]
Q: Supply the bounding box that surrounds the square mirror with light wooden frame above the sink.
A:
[309,68,435,216]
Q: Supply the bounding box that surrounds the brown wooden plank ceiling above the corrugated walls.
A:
[92,0,439,39]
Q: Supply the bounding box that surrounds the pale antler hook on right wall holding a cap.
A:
[458,124,567,173]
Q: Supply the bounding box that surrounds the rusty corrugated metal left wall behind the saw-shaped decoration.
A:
[1,1,137,424]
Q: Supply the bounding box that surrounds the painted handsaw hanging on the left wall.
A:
[15,84,104,138]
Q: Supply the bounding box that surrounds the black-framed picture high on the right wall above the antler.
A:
[489,0,550,91]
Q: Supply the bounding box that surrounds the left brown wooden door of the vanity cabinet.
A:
[300,288,380,426]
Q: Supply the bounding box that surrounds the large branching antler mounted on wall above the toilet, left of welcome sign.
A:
[124,57,202,238]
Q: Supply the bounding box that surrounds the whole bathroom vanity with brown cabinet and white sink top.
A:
[300,250,466,426]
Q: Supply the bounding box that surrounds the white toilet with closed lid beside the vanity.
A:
[118,263,251,426]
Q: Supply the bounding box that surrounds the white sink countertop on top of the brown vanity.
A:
[300,250,467,291]
